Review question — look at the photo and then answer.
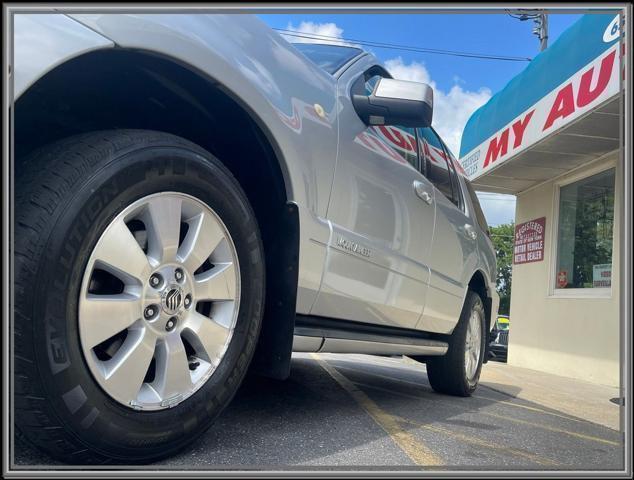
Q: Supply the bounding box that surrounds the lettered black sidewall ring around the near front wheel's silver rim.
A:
[31,146,264,460]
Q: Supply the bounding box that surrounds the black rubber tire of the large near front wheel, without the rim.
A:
[13,130,265,464]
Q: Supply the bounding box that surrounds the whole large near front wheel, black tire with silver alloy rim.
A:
[14,131,264,463]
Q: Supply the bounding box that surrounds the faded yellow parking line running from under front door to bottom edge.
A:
[311,353,444,466]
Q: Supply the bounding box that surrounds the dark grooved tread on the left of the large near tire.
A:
[12,130,262,464]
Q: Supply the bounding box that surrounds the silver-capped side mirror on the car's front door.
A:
[352,78,434,128]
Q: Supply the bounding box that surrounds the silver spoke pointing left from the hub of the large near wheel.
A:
[79,293,142,348]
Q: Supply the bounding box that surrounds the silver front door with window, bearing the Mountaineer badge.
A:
[312,66,435,328]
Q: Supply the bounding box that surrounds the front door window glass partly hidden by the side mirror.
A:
[353,68,419,170]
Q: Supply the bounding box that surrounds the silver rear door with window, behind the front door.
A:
[418,127,477,333]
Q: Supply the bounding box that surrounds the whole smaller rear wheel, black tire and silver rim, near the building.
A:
[427,291,486,397]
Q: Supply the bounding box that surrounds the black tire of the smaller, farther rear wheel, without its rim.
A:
[426,291,487,397]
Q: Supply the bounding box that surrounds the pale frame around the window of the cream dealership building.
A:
[547,161,618,298]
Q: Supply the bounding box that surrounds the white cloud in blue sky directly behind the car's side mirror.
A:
[385,57,491,156]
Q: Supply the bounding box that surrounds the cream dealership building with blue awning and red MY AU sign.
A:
[460,13,624,386]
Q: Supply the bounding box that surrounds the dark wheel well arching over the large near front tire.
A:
[14,48,299,377]
